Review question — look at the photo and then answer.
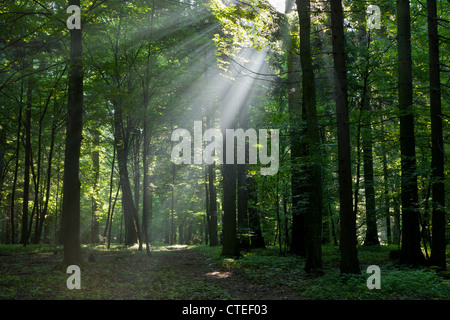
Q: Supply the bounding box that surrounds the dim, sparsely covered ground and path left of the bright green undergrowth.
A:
[0,246,300,300]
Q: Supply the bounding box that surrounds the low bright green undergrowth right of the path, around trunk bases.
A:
[198,246,450,300]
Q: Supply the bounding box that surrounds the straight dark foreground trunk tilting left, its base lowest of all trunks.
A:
[330,0,360,273]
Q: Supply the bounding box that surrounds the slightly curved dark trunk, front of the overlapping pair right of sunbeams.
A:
[297,0,322,272]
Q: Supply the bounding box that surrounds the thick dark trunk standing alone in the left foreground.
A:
[62,0,83,265]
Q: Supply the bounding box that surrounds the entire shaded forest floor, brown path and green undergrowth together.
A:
[0,245,450,300]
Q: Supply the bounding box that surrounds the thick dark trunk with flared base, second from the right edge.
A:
[397,0,425,265]
